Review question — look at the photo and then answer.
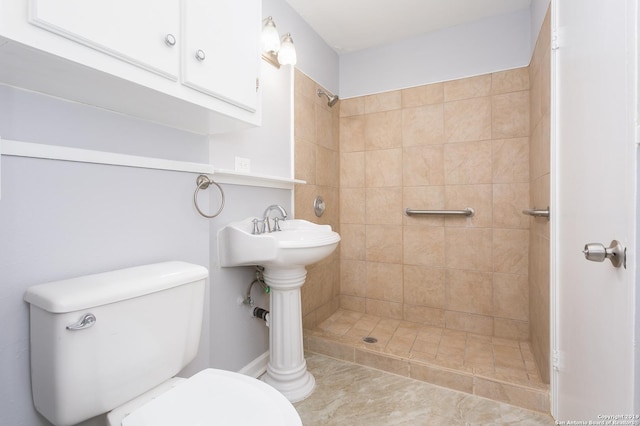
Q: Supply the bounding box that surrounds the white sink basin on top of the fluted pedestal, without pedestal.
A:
[218,217,340,268]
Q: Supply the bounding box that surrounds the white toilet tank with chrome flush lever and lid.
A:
[24,262,208,426]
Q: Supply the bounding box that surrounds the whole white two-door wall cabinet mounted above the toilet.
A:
[0,0,262,134]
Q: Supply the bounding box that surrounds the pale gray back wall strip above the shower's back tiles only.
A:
[340,9,537,98]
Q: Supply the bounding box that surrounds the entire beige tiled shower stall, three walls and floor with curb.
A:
[295,12,550,412]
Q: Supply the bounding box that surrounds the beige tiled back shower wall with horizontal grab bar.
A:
[338,68,531,339]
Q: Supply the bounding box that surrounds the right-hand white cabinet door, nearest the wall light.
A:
[181,0,262,112]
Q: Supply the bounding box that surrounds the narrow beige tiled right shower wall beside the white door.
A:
[529,12,551,383]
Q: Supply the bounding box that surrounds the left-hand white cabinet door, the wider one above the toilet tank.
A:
[29,0,180,81]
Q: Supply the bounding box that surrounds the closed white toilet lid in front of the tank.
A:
[109,368,302,426]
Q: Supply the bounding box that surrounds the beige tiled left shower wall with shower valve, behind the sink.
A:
[294,70,340,328]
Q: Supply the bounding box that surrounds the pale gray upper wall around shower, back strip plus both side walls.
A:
[270,0,550,99]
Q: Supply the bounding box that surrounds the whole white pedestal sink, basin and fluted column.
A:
[218,218,340,402]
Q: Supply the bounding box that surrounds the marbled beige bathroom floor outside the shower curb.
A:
[294,353,555,426]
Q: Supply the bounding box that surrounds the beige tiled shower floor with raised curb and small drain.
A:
[305,310,549,413]
